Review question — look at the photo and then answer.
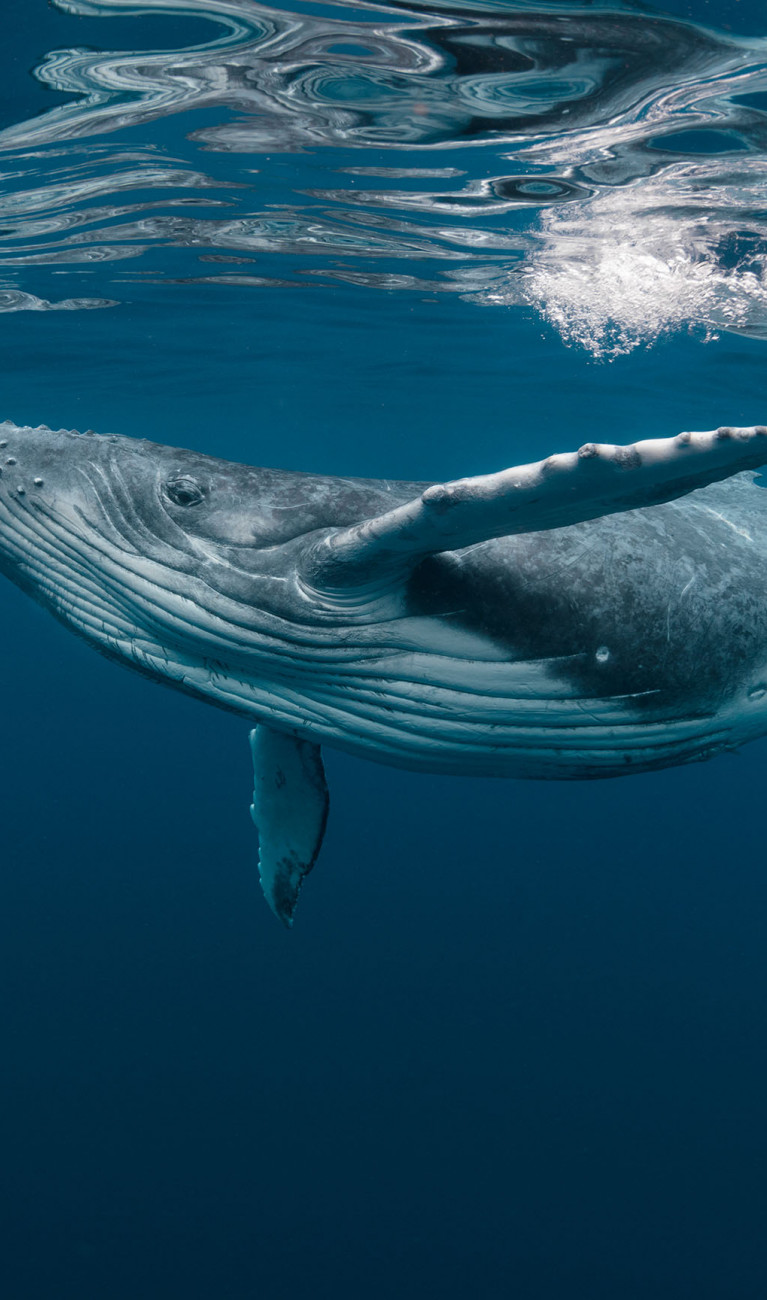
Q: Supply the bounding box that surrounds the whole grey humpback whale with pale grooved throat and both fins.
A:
[0,423,767,924]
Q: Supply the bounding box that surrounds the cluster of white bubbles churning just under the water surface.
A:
[523,170,767,358]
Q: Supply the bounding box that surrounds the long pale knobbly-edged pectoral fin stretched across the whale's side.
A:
[306,425,767,590]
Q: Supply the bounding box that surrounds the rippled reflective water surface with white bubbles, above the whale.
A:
[0,0,767,356]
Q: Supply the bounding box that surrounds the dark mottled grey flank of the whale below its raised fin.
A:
[411,472,767,776]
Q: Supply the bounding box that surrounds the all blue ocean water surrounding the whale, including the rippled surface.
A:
[0,0,767,1300]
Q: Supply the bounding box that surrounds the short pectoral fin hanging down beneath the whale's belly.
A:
[250,724,329,926]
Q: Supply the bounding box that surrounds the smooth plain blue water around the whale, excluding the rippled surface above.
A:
[0,7,767,1300]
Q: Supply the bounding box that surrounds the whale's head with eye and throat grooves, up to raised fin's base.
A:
[0,423,411,689]
